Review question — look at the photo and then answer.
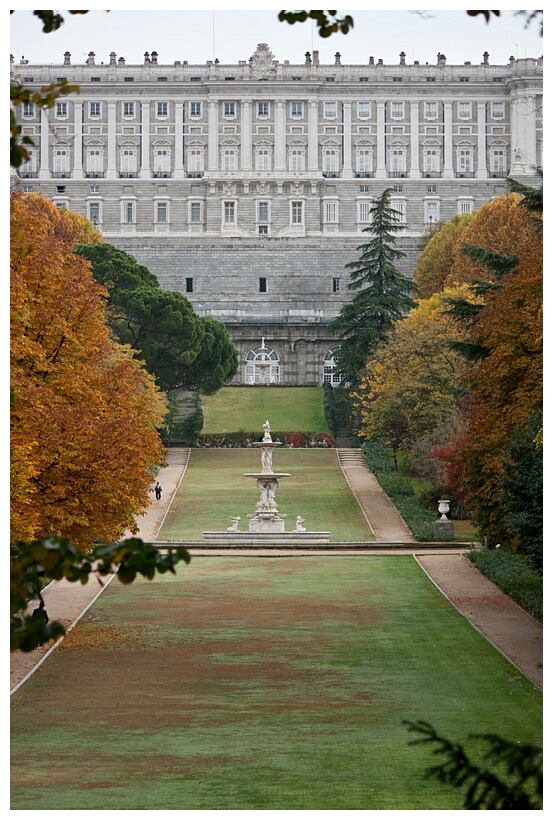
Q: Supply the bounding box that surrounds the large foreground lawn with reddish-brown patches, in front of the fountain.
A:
[11,556,542,811]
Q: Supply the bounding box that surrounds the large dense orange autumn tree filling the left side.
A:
[11,192,165,547]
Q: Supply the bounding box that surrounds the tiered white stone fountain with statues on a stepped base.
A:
[202,421,330,547]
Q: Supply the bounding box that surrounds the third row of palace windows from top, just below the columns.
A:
[81,192,473,227]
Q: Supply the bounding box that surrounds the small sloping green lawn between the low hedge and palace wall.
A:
[202,386,329,436]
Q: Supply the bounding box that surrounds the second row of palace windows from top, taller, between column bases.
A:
[20,143,507,177]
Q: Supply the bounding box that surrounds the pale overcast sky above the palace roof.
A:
[10,2,543,65]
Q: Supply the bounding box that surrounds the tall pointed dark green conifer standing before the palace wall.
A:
[330,188,415,384]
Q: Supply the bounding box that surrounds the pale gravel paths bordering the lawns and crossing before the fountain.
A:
[10,448,543,692]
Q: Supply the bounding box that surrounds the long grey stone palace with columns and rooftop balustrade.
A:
[11,43,543,384]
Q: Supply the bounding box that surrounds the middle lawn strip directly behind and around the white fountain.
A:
[159,447,374,541]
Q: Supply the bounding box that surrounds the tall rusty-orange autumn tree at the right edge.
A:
[442,187,543,540]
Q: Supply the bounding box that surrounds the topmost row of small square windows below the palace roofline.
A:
[23,100,505,120]
